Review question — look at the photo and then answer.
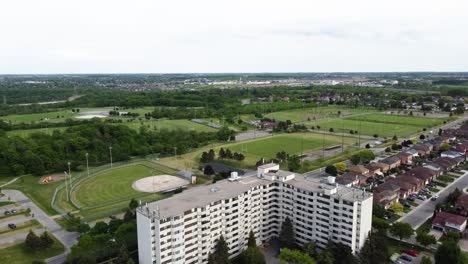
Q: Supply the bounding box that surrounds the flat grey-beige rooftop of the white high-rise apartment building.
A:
[139,170,372,219]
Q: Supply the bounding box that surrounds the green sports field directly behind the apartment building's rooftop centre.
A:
[229,133,357,160]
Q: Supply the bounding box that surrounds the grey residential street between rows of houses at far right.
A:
[398,171,468,229]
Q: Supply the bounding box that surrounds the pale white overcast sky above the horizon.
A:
[0,0,468,74]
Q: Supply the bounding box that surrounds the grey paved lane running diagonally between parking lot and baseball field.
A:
[2,190,78,264]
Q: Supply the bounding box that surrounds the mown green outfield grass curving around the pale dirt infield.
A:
[72,162,175,207]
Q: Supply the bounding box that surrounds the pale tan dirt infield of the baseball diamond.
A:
[132,175,189,193]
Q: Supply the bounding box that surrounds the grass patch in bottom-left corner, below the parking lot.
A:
[0,234,65,264]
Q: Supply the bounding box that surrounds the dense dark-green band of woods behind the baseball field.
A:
[0,123,234,175]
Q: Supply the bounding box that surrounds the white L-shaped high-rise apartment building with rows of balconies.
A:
[137,164,373,264]
